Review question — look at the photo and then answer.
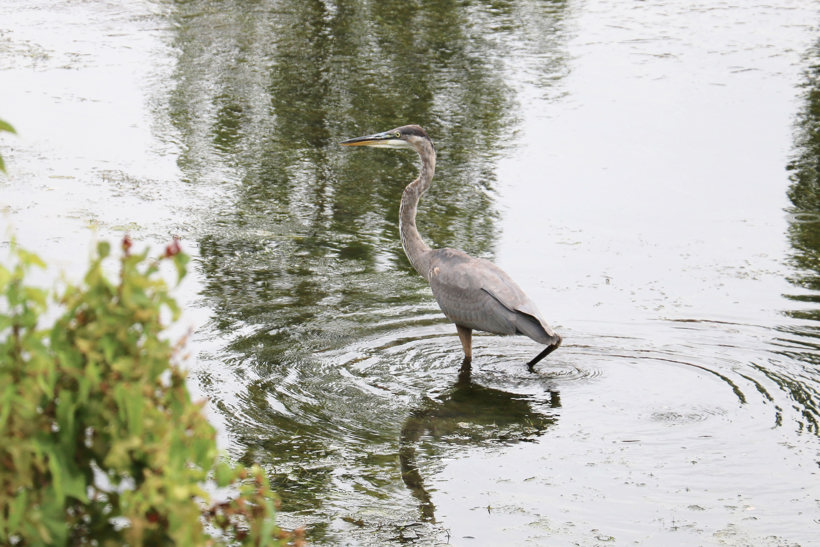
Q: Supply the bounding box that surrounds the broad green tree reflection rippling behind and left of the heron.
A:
[170,0,565,541]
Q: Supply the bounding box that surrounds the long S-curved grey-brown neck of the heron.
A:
[399,142,436,279]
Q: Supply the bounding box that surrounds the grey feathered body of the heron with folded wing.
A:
[428,249,555,344]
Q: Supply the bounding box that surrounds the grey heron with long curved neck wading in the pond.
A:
[340,125,561,369]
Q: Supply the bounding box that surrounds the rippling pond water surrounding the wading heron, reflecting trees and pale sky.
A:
[0,0,820,545]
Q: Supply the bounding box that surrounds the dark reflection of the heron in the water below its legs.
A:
[399,364,561,521]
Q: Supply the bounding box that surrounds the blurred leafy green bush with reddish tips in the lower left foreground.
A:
[0,238,301,546]
